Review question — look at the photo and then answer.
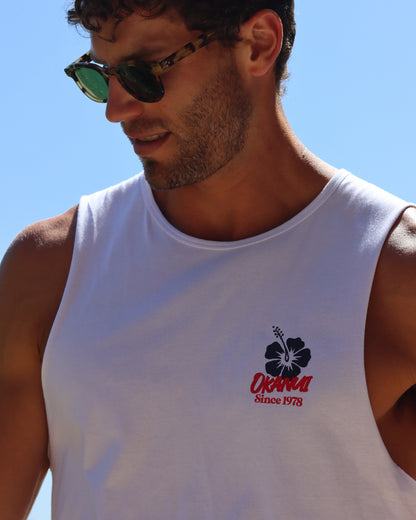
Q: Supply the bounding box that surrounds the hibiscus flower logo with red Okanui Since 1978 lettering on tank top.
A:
[250,327,313,406]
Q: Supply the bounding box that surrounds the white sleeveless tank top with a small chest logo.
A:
[43,171,416,520]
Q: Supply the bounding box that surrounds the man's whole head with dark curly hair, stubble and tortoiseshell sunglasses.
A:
[66,0,293,190]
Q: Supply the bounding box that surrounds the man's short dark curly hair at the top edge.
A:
[67,0,296,89]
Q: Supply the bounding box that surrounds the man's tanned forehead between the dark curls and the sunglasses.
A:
[91,13,195,65]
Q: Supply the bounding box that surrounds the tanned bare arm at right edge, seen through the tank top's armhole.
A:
[366,208,416,479]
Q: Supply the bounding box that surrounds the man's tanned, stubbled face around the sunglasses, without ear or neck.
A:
[92,13,252,190]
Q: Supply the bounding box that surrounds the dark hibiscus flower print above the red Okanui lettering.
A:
[266,327,311,379]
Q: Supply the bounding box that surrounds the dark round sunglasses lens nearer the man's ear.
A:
[116,63,164,103]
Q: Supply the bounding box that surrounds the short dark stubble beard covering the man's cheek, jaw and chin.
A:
[133,52,251,189]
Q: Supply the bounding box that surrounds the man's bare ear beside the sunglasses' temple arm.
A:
[240,9,283,76]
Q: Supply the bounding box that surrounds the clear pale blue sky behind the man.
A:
[0,0,416,520]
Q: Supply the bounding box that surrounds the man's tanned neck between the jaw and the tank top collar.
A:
[154,104,334,241]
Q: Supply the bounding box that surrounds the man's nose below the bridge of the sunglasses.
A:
[105,76,144,123]
